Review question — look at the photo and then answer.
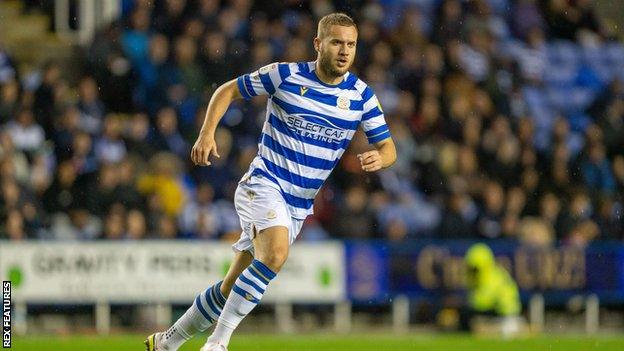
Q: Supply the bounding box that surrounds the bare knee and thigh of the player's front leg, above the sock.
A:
[253,225,290,272]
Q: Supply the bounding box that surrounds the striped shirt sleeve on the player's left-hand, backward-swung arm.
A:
[236,62,290,100]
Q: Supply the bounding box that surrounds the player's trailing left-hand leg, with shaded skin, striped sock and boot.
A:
[146,251,253,351]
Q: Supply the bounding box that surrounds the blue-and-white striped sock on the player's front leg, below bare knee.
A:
[208,260,275,346]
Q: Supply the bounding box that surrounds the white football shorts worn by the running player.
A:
[232,175,304,255]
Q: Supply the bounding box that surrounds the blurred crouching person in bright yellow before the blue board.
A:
[462,244,522,335]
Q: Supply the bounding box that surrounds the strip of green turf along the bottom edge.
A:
[13,334,624,351]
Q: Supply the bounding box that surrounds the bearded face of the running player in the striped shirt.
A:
[315,25,357,77]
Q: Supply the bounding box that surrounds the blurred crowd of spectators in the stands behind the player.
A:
[0,0,624,245]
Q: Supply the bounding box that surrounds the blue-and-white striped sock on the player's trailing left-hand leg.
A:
[159,281,226,350]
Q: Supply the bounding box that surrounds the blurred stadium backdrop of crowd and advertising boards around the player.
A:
[0,0,624,350]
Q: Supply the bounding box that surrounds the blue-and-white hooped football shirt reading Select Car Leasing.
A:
[237,62,390,219]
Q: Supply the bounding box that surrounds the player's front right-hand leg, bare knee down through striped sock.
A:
[207,226,290,350]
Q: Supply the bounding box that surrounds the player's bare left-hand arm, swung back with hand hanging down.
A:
[191,79,243,166]
